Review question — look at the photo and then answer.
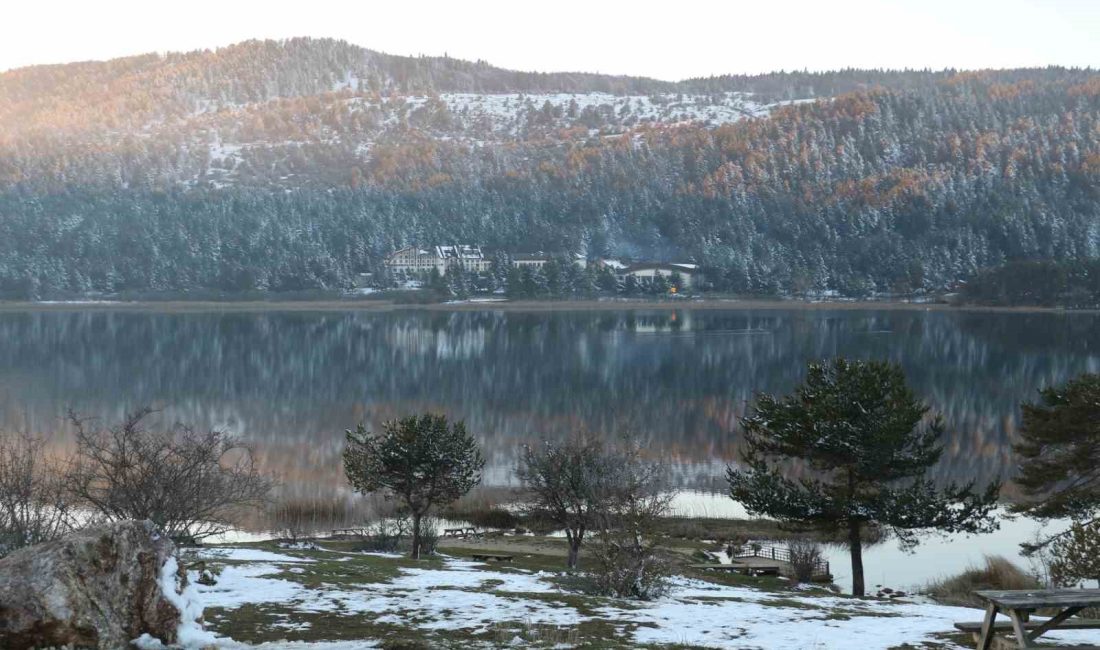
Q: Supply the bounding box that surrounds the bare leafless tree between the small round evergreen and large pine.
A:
[516,436,611,569]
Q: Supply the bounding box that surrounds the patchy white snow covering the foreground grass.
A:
[184,549,1100,650]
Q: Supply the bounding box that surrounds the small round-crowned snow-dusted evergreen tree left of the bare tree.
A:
[343,414,485,559]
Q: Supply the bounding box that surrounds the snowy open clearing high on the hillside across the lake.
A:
[189,87,813,186]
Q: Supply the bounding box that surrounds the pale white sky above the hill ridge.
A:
[0,0,1100,79]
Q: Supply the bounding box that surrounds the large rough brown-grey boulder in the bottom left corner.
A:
[0,521,180,650]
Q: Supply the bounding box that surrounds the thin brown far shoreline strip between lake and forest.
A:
[0,298,1100,313]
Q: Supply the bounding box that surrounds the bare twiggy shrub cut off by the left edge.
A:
[0,432,74,555]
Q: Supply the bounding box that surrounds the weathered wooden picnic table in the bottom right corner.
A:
[956,590,1100,650]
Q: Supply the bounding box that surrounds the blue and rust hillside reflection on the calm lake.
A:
[0,310,1100,486]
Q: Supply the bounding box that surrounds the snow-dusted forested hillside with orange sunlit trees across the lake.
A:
[0,38,1100,297]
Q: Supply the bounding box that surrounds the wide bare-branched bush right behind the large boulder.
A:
[67,408,273,539]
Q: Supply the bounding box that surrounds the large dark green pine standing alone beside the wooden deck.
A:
[727,359,1000,596]
